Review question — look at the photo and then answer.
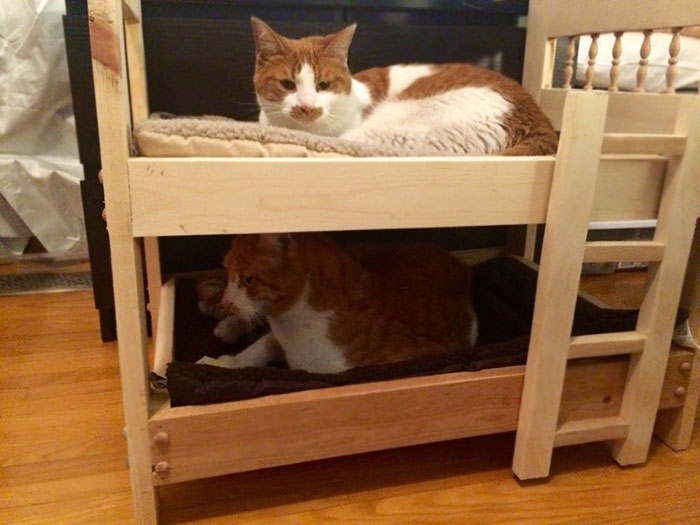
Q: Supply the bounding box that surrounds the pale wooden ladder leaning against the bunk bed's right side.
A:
[513,91,700,480]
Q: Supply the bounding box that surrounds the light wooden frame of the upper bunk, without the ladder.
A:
[90,0,700,237]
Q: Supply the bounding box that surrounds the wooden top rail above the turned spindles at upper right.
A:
[541,0,700,38]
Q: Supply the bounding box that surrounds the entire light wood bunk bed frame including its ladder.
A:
[88,0,700,523]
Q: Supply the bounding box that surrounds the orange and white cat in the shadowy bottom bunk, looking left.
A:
[199,233,477,373]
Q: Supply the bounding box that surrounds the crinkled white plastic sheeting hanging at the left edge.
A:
[0,0,87,257]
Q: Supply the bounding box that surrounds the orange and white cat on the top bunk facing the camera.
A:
[251,18,557,155]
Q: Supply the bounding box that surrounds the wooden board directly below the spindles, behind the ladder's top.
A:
[540,88,690,134]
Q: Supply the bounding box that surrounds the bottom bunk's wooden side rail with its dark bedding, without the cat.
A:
[149,254,693,485]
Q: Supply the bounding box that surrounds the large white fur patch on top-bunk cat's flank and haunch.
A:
[342,87,512,155]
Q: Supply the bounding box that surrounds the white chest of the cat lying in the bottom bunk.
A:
[268,286,350,373]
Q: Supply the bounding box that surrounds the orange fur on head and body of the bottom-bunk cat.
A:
[225,233,475,365]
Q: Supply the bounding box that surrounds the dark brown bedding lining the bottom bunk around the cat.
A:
[161,256,664,406]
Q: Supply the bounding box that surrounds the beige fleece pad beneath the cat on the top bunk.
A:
[134,116,446,157]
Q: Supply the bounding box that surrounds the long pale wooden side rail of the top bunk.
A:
[129,157,554,236]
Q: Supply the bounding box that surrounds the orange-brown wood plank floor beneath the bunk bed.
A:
[0,272,700,524]
